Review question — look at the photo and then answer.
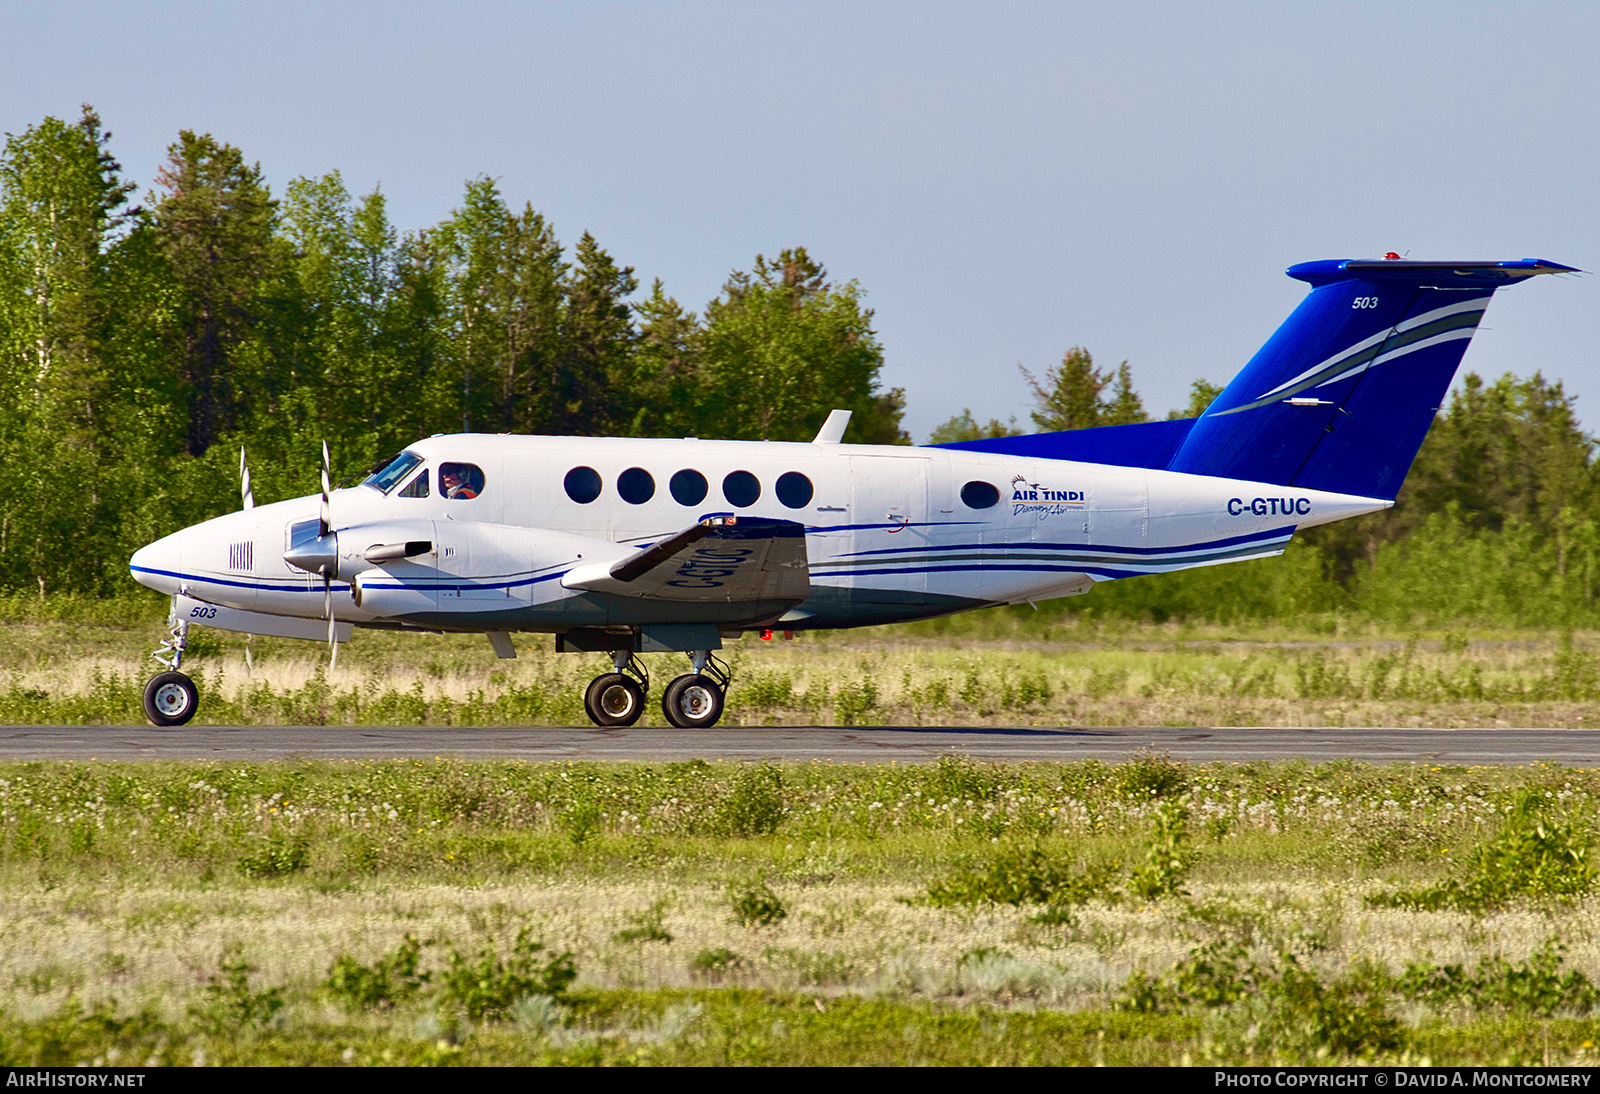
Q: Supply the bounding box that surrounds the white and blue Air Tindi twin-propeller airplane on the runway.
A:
[130,253,1578,728]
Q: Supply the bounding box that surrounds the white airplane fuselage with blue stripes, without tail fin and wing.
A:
[130,433,1390,632]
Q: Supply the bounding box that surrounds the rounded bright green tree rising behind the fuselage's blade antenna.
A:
[701,248,906,445]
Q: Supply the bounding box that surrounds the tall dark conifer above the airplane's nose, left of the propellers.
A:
[150,130,282,456]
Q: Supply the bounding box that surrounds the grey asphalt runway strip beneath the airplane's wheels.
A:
[0,726,1600,766]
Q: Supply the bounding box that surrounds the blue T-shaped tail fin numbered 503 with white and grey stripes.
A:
[1168,259,1573,499]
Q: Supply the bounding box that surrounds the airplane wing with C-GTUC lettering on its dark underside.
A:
[562,517,811,603]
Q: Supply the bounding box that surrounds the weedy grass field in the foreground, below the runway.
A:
[0,755,1600,1065]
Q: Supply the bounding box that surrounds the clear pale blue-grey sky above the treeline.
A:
[0,0,1600,441]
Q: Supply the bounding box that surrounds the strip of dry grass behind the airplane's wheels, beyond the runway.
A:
[9,598,1600,726]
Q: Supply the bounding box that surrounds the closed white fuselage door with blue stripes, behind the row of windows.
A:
[850,456,933,605]
